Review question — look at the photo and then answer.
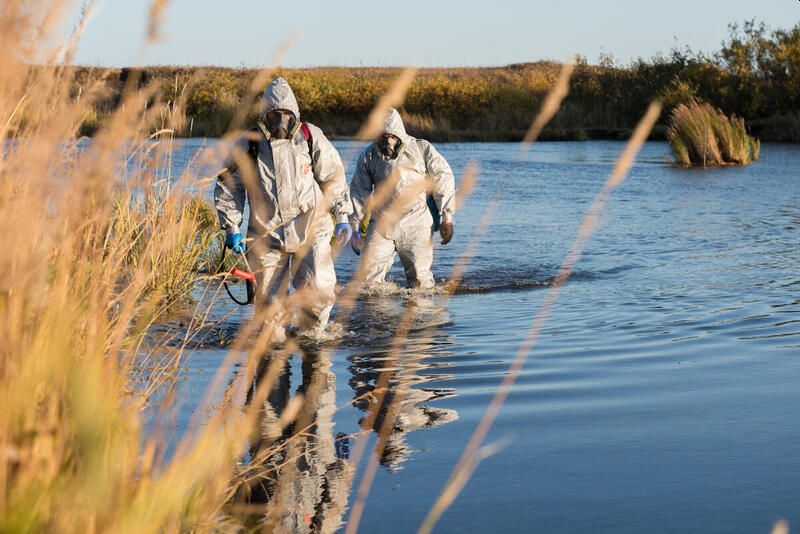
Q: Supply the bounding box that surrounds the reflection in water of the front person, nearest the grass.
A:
[242,352,352,532]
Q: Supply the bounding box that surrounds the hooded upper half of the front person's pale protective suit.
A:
[215,77,352,252]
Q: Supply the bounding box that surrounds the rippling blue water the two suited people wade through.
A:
[161,141,800,532]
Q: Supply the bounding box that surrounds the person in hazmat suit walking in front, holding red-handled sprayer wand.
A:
[214,77,352,342]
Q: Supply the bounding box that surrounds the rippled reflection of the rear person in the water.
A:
[349,299,458,471]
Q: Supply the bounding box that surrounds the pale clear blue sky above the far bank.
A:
[69,0,800,67]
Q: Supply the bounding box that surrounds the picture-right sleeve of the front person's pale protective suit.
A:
[309,125,353,224]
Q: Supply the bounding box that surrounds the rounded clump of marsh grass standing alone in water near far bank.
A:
[667,99,761,167]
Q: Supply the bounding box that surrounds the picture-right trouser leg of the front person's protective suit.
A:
[292,232,336,328]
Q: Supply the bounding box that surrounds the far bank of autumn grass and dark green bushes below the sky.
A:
[56,23,800,142]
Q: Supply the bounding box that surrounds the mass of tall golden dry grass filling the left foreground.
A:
[0,1,258,532]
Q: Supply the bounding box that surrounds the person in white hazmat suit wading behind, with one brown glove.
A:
[350,109,456,289]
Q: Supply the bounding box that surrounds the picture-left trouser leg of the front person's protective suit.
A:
[247,247,289,342]
